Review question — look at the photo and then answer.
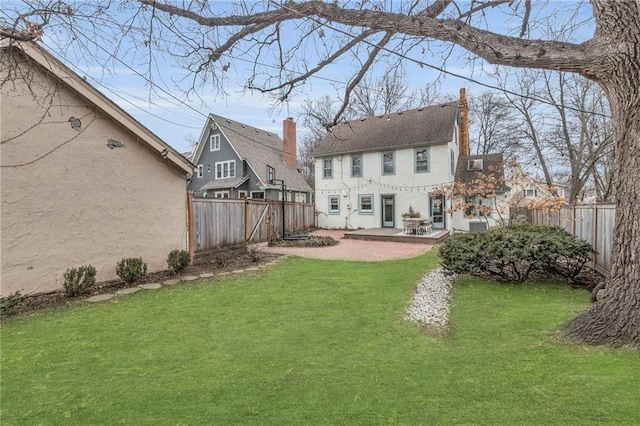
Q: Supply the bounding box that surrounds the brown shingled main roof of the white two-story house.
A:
[313,101,459,156]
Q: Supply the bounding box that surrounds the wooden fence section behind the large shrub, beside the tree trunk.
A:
[527,204,616,275]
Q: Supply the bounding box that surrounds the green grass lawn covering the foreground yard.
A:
[0,254,640,426]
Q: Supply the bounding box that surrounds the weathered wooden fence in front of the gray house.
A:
[189,196,315,259]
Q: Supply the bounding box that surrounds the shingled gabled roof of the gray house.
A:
[193,114,311,192]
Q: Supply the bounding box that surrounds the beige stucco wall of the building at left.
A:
[0,59,187,295]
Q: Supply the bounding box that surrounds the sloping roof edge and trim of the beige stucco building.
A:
[0,38,194,173]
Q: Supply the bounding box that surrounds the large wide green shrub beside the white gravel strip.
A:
[440,223,591,283]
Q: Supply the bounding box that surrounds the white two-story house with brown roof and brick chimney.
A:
[314,89,469,230]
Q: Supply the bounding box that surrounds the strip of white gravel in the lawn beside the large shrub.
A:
[406,268,454,328]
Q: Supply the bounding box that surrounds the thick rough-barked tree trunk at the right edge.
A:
[566,1,640,347]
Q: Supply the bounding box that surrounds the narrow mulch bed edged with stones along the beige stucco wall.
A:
[3,251,281,317]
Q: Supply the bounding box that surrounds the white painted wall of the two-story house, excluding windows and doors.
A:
[315,141,458,229]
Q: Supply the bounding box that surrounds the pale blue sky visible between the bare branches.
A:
[0,0,596,152]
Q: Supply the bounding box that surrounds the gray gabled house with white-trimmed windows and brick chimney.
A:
[188,114,312,203]
